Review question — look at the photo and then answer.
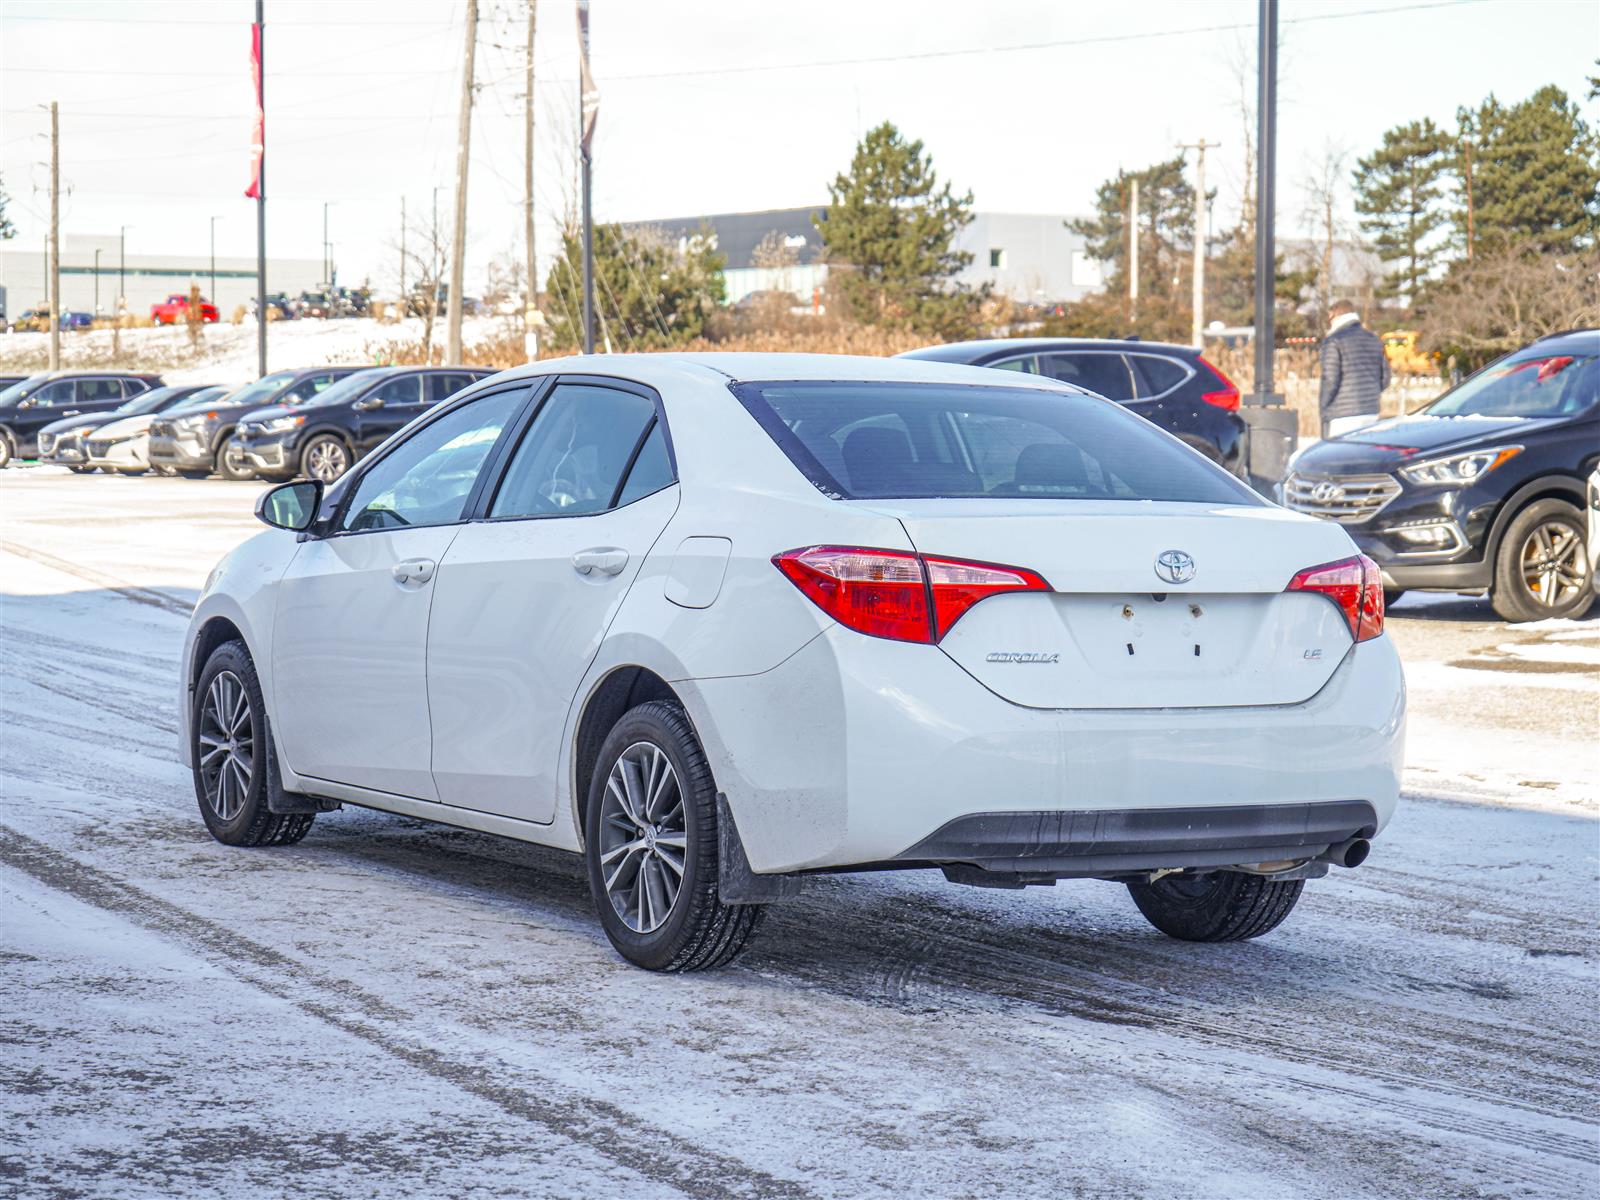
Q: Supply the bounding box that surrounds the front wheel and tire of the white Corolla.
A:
[189,642,315,846]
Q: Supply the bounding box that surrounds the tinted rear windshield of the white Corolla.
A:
[734,382,1261,504]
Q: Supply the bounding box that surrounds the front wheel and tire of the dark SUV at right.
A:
[1490,499,1592,621]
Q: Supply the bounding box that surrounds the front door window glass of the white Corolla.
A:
[339,390,525,533]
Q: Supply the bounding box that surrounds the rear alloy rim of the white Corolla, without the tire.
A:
[600,742,688,933]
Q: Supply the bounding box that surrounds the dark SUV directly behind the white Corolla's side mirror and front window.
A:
[227,366,494,483]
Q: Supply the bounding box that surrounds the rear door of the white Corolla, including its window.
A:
[427,384,678,822]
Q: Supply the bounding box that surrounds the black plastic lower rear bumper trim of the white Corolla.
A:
[888,800,1378,877]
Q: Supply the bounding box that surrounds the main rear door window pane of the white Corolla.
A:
[490,384,656,517]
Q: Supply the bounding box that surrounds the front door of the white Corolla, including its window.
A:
[272,389,526,800]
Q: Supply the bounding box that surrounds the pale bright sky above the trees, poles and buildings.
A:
[0,0,1600,291]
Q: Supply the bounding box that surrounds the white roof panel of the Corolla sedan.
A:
[494,350,1078,392]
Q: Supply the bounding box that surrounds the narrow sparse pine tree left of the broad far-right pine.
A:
[1354,117,1453,302]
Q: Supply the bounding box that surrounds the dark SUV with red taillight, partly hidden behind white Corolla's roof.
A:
[899,338,1248,478]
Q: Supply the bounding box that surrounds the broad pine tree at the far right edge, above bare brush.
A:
[1456,85,1600,253]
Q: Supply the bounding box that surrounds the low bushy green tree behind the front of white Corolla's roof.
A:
[546,224,728,350]
